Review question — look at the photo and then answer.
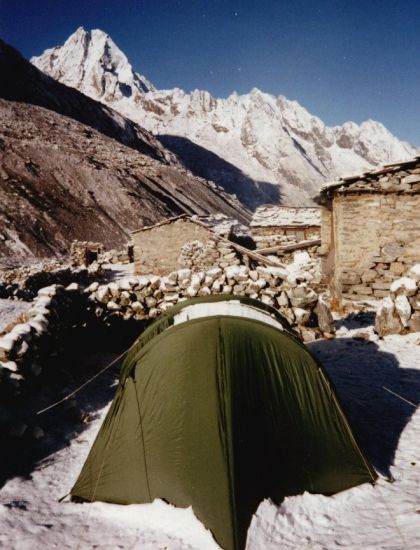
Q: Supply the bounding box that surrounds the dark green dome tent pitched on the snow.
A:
[71,296,376,549]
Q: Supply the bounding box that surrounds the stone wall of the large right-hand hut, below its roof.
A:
[332,193,420,298]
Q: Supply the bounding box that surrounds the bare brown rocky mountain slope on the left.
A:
[0,99,247,265]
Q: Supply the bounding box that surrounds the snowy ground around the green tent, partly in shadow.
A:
[0,315,420,550]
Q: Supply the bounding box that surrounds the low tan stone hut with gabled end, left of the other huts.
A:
[132,214,240,275]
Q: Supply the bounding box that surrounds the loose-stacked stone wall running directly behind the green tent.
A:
[86,252,335,341]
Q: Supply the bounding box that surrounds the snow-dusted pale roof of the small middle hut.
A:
[251,204,321,228]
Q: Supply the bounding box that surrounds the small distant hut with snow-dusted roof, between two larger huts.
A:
[251,204,321,249]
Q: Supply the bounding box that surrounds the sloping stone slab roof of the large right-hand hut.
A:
[314,156,420,204]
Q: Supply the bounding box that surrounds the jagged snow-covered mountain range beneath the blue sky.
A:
[31,28,418,207]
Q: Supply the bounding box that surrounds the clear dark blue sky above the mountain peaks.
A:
[0,0,420,145]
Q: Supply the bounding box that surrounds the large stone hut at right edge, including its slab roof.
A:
[315,157,420,300]
